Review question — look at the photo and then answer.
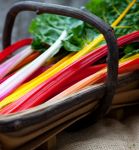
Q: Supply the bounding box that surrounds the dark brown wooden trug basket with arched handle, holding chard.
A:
[0,2,139,150]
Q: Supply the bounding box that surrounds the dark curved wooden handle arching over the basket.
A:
[3,1,118,119]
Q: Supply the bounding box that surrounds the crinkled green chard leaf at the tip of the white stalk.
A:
[29,14,97,52]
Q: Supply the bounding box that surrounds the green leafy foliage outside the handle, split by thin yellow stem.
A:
[86,0,139,37]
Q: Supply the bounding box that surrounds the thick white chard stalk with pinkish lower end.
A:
[0,31,67,100]
